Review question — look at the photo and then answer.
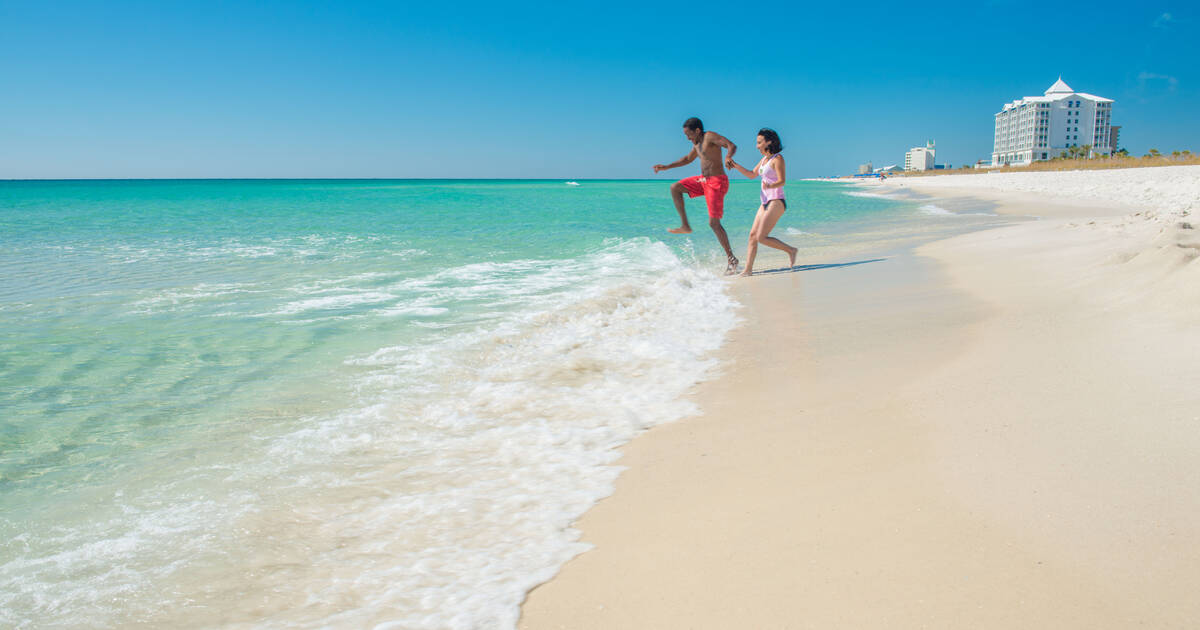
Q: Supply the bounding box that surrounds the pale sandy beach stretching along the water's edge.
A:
[520,167,1200,630]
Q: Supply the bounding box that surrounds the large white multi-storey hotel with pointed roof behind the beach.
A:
[991,77,1112,167]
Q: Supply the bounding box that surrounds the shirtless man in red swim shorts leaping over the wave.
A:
[654,118,738,274]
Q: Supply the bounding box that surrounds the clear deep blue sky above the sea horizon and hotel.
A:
[0,0,1200,179]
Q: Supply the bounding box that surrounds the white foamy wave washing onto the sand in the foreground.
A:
[0,239,737,629]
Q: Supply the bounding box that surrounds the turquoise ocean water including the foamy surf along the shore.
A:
[0,180,1000,629]
